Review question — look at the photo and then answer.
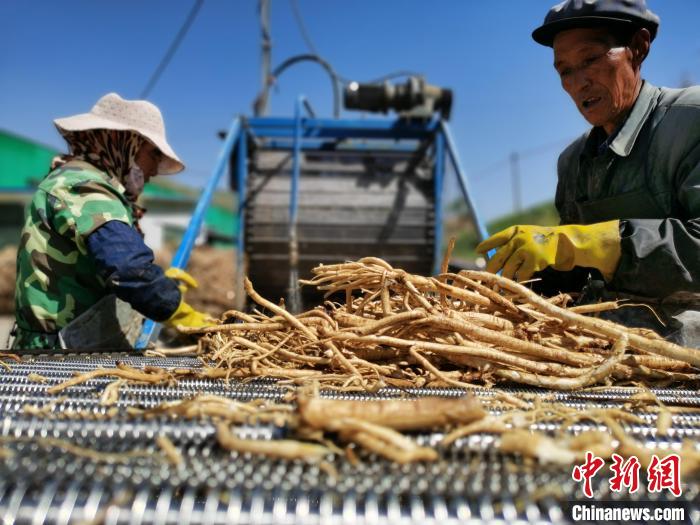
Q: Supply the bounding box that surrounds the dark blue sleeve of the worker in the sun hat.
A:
[87,221,181,321]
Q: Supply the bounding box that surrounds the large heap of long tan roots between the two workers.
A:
[183,257,700,391]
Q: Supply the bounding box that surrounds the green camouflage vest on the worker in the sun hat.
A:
[15,160,133,333]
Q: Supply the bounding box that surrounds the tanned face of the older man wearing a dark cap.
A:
[553,28,639,134]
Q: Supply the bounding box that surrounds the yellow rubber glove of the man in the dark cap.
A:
[476,220,621,281]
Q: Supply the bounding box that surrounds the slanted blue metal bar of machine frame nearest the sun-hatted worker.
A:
[135,117,241,350]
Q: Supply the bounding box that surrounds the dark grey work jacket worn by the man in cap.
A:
[555,82,700,346]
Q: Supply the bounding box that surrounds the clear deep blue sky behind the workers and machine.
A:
[0,0,700,220]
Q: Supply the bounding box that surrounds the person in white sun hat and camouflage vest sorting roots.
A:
[12,93,210,349]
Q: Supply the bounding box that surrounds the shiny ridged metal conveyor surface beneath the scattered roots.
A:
[0,355,700,525]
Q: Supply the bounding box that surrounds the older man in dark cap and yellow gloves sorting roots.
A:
[477,0,700,347]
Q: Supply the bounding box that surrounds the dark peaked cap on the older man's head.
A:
[532,0,659,47]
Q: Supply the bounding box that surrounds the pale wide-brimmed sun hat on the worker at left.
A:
[53,93,185,175]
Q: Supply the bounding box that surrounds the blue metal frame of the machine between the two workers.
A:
[136,103,488,349]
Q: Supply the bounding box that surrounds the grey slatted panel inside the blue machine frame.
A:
[245,146,435,304]
